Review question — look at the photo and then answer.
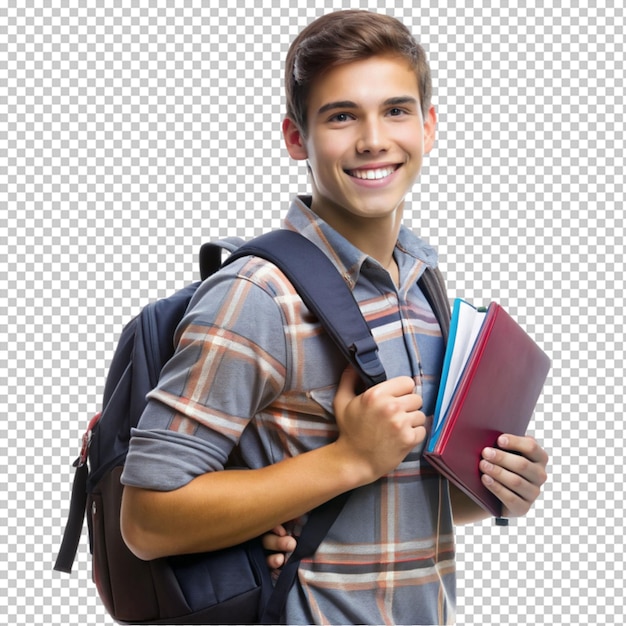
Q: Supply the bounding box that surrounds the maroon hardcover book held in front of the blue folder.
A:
[425,301,550,517]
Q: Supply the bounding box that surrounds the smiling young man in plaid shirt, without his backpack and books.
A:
[122,11,547,624]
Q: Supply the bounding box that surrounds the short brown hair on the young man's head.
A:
[285,10,432,135]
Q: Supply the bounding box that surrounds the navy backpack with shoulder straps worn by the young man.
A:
[54,230,450,624]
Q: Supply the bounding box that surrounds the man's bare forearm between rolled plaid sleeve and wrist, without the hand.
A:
[121,442,368,559]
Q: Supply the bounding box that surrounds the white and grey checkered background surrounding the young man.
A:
[0,0,626,625]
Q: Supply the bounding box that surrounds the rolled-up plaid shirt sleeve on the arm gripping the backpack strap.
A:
[122,259,287,491]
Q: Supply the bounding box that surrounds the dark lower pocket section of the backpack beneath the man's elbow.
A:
[87,466,273,624]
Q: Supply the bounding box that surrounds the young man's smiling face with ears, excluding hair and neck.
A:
[283,56,436,235]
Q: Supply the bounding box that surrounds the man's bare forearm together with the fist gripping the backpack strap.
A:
[121,368,426,559]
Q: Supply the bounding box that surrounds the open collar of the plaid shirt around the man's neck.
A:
[283,196,437,288]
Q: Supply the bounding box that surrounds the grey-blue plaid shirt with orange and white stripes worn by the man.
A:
[122,198,455,624]
